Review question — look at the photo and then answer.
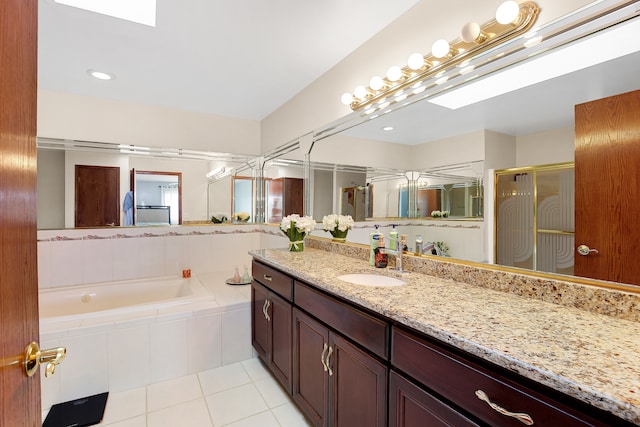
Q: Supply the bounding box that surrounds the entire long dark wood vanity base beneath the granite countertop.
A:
[252,261,632,427]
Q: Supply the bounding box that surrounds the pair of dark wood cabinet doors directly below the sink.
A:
[293,308,387,427]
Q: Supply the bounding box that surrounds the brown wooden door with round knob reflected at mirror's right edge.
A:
[575,91,640,285]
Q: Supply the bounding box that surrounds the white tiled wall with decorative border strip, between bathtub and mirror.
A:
[38,224,286,288]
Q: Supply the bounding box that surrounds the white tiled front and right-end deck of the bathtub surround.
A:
[40,272,254,409]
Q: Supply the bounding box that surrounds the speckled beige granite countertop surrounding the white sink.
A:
[250,249,640,425]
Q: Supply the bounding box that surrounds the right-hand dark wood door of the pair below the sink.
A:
[327,332,387,427]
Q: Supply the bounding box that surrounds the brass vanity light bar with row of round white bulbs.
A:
[341,1,540,111]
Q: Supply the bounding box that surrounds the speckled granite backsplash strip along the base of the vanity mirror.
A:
[305,237,640,322]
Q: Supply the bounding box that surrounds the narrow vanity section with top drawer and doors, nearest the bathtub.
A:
[251,263,292,393]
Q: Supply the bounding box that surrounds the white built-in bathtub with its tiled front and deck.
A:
[39,272,255,409]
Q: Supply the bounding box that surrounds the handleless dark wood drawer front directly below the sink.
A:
[295,280,390,360]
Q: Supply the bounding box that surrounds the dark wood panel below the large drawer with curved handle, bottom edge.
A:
[389,371,478,427]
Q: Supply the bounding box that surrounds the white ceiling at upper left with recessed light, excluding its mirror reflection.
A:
[38,0,418,120]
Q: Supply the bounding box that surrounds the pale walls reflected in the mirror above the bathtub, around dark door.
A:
[37,137,251,229]
